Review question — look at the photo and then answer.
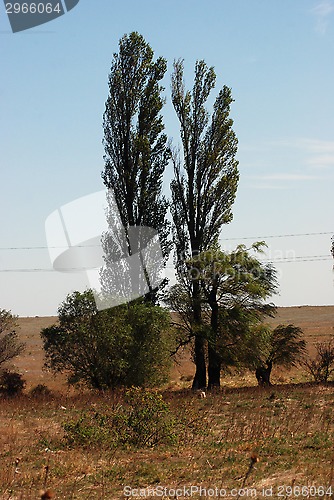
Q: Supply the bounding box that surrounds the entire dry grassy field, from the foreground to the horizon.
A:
[0,306,334,500]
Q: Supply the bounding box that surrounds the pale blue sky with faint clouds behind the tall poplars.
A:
[0,0,334,316]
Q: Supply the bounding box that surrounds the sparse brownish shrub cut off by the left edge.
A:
[0,309,25,366]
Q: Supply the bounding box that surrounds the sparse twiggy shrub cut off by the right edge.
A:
[304,337,334,383]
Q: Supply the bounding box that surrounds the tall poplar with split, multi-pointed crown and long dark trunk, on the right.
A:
[171,60,239,389]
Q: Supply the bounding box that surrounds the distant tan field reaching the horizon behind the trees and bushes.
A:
[15,306,334,390]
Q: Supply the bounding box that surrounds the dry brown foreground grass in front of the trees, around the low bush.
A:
[0,384,334,499]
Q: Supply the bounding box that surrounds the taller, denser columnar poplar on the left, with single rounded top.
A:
[102,32,170,304]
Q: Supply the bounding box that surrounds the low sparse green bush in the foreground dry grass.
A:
[63,388,176,448]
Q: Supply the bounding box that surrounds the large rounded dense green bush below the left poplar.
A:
[41,290,170,390]
